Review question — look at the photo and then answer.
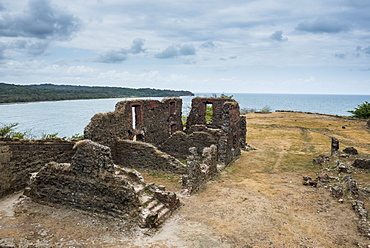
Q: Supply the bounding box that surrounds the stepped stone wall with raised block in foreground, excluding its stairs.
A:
[27,140,139,219]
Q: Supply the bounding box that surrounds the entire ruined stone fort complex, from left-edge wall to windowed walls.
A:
[0,97,246,227]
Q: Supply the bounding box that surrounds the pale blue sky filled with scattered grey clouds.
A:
[0,0,370,95]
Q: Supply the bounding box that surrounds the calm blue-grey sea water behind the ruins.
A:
[0,93,370,137]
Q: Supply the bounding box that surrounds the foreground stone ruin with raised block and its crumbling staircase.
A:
[25,140,180,227]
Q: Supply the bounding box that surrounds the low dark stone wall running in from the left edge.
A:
[0,138,75,197]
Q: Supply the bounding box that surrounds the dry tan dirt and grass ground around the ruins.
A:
[0,113,370,247]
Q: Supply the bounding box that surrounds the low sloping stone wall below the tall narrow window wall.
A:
[113,140,186,174]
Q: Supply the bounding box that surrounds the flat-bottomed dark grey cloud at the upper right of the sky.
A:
[295,18,349,33]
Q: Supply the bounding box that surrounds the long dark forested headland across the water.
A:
[0,83,194,103]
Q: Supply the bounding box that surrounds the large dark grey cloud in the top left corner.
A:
[0,0,81,40]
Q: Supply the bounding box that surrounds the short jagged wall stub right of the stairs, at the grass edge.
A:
[182,145,217,193]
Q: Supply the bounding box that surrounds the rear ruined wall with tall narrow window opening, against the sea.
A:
[84,98,182,147]
